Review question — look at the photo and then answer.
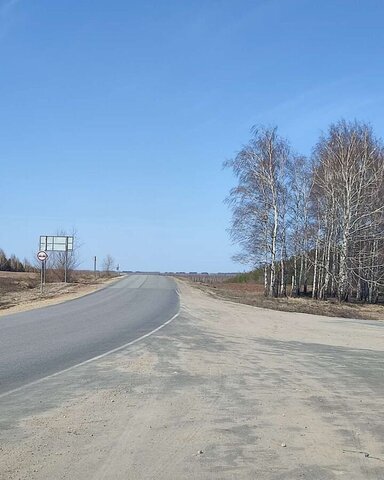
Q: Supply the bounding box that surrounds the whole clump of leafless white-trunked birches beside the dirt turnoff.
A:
[224,120,384,303]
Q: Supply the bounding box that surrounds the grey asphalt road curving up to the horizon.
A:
[0,275,179,395]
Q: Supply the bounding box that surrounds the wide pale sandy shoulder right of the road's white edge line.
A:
[0,282,384,480]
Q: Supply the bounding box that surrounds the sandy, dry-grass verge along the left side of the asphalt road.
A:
[0,272,119,316]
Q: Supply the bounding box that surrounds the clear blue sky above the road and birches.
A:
[0,0,384,271]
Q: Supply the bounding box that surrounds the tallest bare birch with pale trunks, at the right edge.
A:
[314,120,384,301]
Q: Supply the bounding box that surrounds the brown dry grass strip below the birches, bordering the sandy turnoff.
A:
[192,282,384,320]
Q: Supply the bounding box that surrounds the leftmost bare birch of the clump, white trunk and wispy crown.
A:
[225,127,289,295]
